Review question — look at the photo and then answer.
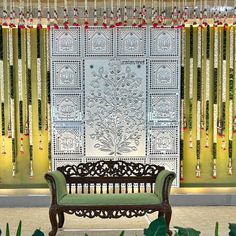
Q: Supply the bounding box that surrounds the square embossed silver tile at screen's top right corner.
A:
[150,27,180,57]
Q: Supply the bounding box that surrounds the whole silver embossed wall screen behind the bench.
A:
[51,26,181,186]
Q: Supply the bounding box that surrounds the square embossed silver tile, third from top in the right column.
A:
[150,93,179,122]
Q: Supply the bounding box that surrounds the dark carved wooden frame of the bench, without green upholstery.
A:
[45,161,175,236]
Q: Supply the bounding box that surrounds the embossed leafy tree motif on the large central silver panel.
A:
[86,60,145,156]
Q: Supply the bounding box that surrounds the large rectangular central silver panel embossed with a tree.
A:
[85,59,146,156]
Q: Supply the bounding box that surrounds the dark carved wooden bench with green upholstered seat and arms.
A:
[45,161,175,236]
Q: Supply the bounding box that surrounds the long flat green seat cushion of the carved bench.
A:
[59,193,161,206]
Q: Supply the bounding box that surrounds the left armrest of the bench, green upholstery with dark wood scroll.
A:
[45,171,67,205]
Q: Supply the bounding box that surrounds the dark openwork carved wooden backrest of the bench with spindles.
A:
[57,161,165,194]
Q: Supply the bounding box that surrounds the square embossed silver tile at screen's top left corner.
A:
[51,28,81,56]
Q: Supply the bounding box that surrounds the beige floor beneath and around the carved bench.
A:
[0,206,236,236]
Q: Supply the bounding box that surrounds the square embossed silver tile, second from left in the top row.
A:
[85,27,114,56]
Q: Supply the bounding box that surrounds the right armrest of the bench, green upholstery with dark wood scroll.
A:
[154,170,176,203]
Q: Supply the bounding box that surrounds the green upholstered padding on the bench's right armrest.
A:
[154,170,176,202]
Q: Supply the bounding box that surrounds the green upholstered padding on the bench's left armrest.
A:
[48,171,67,202]
